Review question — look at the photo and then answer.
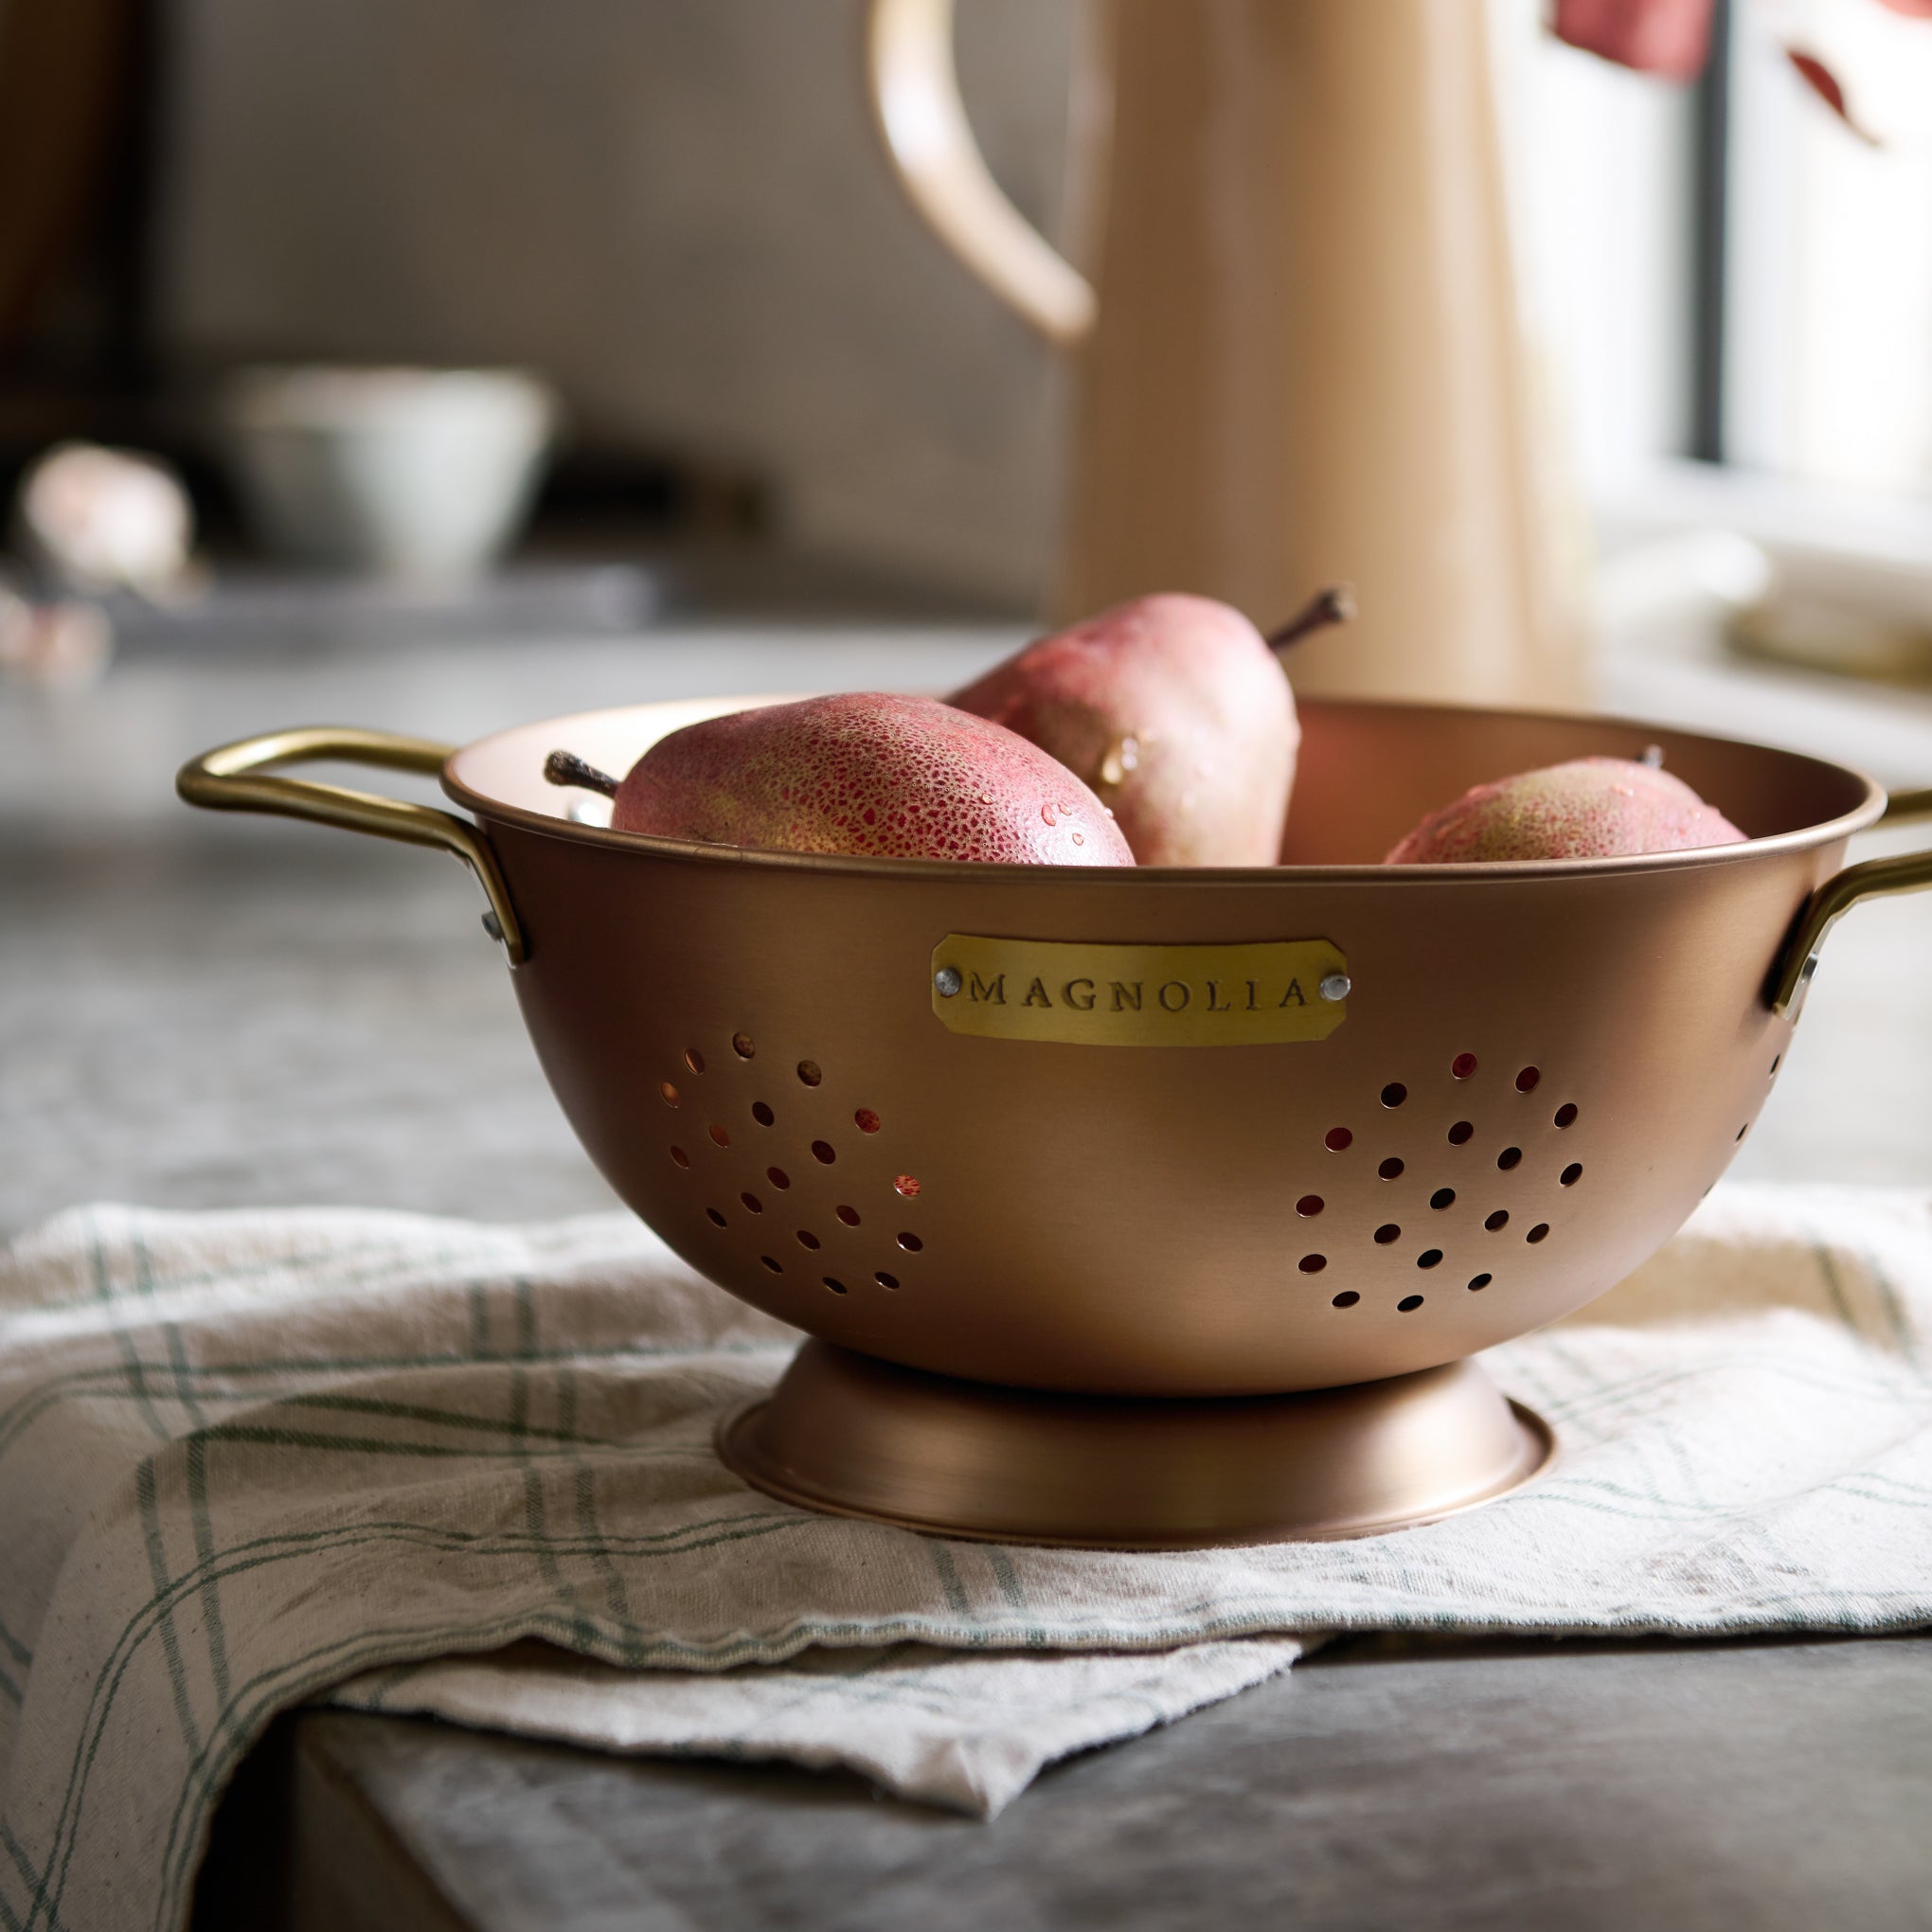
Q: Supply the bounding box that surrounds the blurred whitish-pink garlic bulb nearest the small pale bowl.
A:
[17,442,193,595]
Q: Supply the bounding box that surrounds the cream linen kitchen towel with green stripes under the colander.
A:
[0,1187,1932,1932]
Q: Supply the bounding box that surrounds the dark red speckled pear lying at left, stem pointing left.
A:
[545,691,1134,866]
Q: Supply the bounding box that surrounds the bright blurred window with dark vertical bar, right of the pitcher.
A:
[1522,0,1932,500]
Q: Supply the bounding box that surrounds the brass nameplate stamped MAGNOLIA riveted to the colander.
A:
[933,933,1349,1047]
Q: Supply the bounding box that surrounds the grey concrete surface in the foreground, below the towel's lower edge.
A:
[197,1637,1932,1932]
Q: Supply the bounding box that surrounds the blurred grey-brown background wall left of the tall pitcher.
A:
[160,0,1076,607]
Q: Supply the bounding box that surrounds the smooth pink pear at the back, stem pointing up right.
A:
[947,591,1351,866]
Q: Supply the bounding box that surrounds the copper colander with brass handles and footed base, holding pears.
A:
[182,699,1932,1546]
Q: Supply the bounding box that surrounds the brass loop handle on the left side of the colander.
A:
[174,724,528,966]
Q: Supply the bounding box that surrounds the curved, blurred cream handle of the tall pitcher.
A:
[866,0,1094,348]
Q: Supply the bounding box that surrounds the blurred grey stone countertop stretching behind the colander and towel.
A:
[0,624,1932,1230]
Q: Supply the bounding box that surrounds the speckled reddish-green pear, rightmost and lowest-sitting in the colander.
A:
[1384,754,1746,866]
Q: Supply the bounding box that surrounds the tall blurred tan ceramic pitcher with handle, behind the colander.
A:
[868,0,1581,704]
